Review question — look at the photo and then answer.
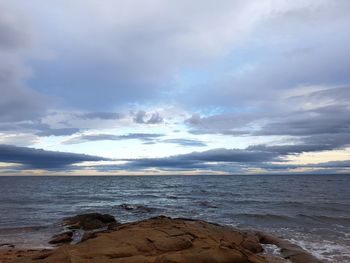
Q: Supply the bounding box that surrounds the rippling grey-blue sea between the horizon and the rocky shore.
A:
[0,175,350,263]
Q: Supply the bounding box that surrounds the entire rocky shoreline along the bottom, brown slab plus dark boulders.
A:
[0,213,321,263]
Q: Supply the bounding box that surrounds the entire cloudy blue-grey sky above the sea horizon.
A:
[0,0,350,176]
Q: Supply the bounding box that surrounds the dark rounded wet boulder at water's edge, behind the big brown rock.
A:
[63,213,117,230]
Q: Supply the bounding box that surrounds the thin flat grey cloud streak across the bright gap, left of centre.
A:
[65,133,164,144]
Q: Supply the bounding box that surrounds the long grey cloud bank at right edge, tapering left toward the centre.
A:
[185,86,350,144]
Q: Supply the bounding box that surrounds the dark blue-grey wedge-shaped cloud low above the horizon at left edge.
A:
[0,145,107,170]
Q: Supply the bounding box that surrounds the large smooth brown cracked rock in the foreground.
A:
[10,217,268,263]
